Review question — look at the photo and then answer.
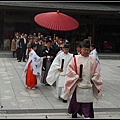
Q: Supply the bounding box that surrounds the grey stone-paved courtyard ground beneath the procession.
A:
[0,53,120,119]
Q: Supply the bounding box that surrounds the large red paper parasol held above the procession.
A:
[34,10,79,31]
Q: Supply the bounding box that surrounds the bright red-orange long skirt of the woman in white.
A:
[26,60,37,88]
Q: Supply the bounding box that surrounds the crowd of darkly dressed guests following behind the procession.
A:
[11,32,65,62]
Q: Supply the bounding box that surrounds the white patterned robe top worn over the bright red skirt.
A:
[23,49,43,78]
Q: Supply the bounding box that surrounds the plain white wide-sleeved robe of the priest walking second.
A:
[46,52,73,97]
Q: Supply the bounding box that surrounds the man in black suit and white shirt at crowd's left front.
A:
[18,34,27,62]
